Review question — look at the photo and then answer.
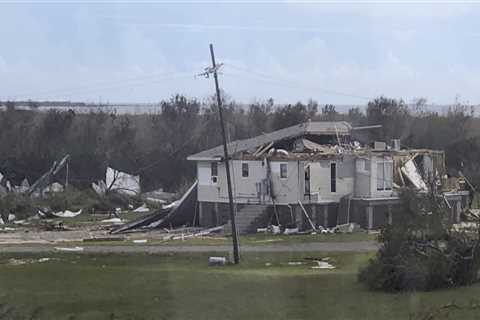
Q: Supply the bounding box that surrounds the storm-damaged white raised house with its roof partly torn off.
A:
[188,121,469,233]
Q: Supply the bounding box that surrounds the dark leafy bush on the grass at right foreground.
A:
[358,190,480,291]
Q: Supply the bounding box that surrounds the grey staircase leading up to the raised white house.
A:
[225,204,268,234]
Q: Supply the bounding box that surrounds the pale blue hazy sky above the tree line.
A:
[0,1,480,104]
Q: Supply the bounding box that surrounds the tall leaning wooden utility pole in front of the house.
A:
[200,44,240,264]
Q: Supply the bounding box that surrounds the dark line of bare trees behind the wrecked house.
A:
[0,95,480,191]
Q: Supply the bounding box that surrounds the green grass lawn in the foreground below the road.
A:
[0,252,480,320]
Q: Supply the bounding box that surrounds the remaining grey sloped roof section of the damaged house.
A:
[187,121,352,161]
